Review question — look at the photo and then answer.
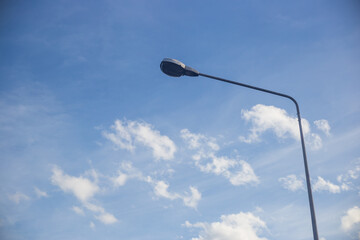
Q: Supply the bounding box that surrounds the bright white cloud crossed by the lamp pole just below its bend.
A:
[239,104,325,149]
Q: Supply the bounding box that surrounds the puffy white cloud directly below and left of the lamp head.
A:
[103,120,176,160]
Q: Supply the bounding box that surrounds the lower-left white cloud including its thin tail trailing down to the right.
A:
[51,166,117,224]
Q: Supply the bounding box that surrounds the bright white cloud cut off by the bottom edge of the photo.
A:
[184,212,266,240]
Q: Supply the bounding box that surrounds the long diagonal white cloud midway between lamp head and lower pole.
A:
[181,129,259,186]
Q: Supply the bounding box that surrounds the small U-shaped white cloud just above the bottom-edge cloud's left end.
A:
[154,181,201,209]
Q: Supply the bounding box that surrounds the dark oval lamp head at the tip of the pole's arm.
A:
[160,58,199,77]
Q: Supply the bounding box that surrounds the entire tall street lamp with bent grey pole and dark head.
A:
[160,58,319,240]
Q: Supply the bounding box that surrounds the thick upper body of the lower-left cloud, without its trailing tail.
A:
[51,167,100,202]
